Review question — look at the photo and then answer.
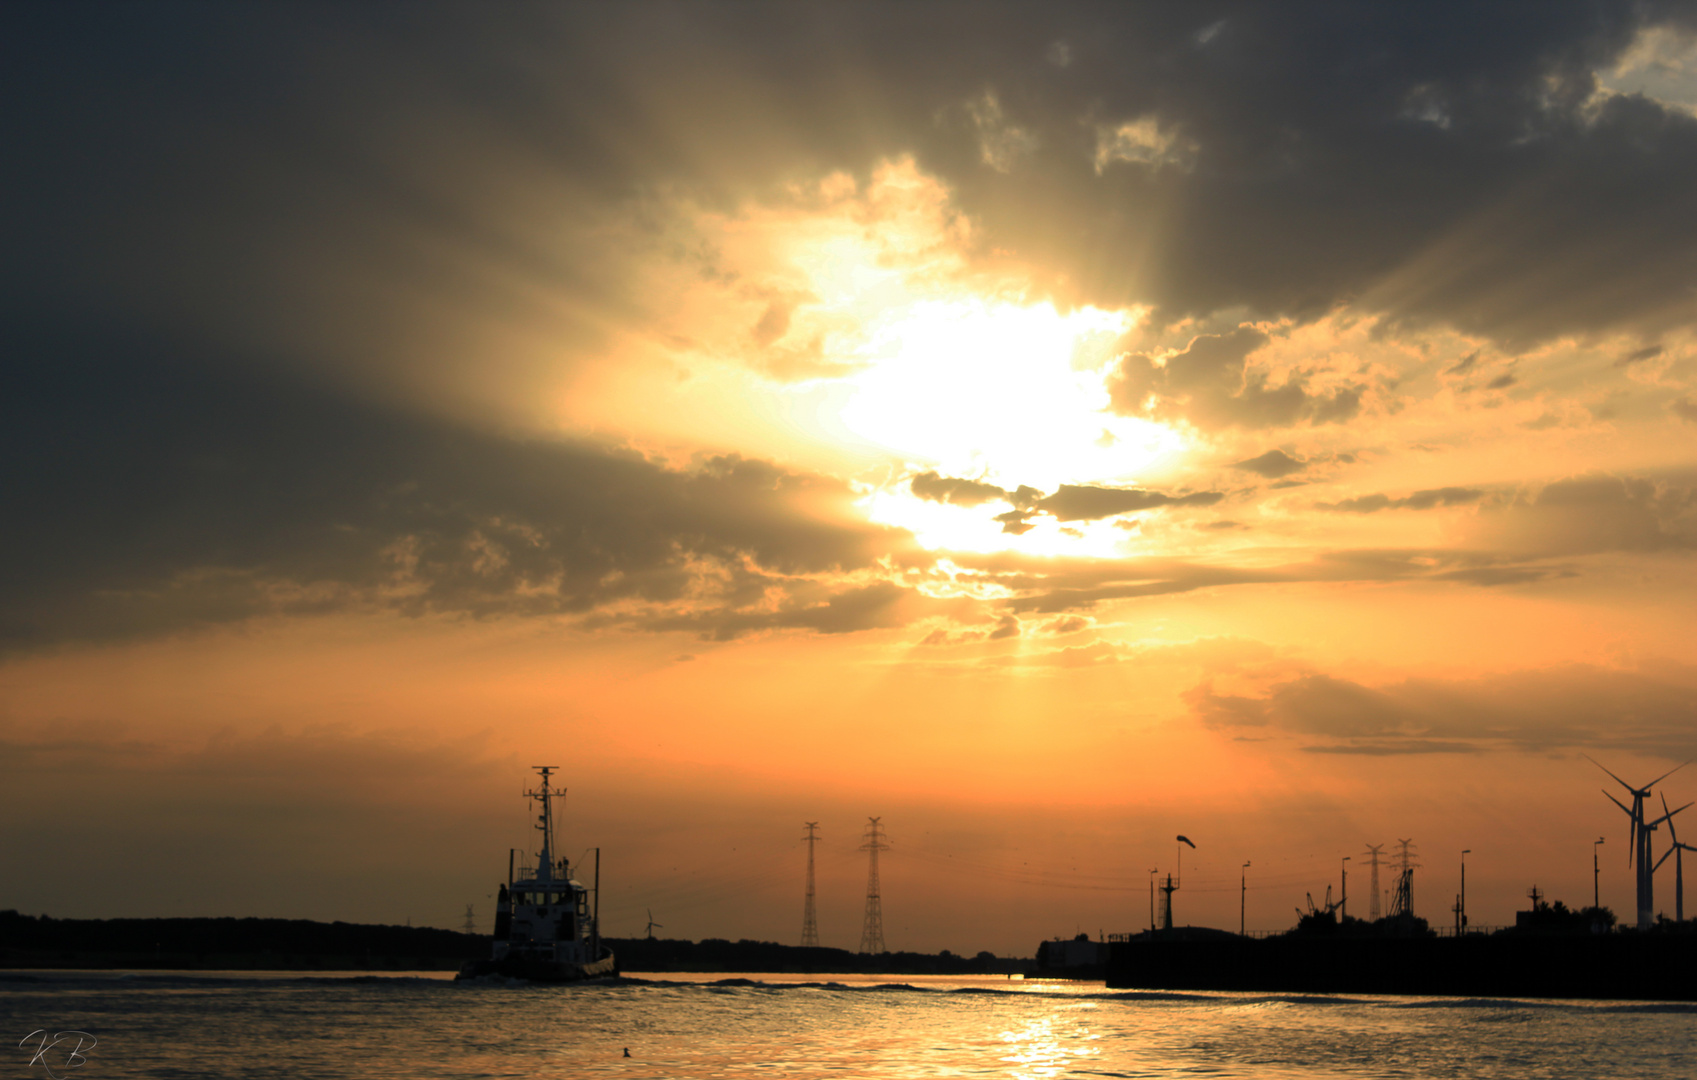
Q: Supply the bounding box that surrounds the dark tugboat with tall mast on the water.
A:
[455,766,619,983]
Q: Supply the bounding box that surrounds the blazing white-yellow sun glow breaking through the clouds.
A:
[614,160,1188,555]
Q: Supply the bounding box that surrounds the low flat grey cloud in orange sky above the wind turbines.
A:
[1185,664,1697,757]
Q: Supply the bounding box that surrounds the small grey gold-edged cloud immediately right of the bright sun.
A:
[1108,326,1364,430]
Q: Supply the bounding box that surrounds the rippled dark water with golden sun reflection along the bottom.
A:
[0,971,1697,1080]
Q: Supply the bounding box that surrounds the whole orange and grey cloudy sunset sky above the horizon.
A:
[0,0,1697,954]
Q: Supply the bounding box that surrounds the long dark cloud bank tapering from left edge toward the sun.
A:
[0,329,908,647]
